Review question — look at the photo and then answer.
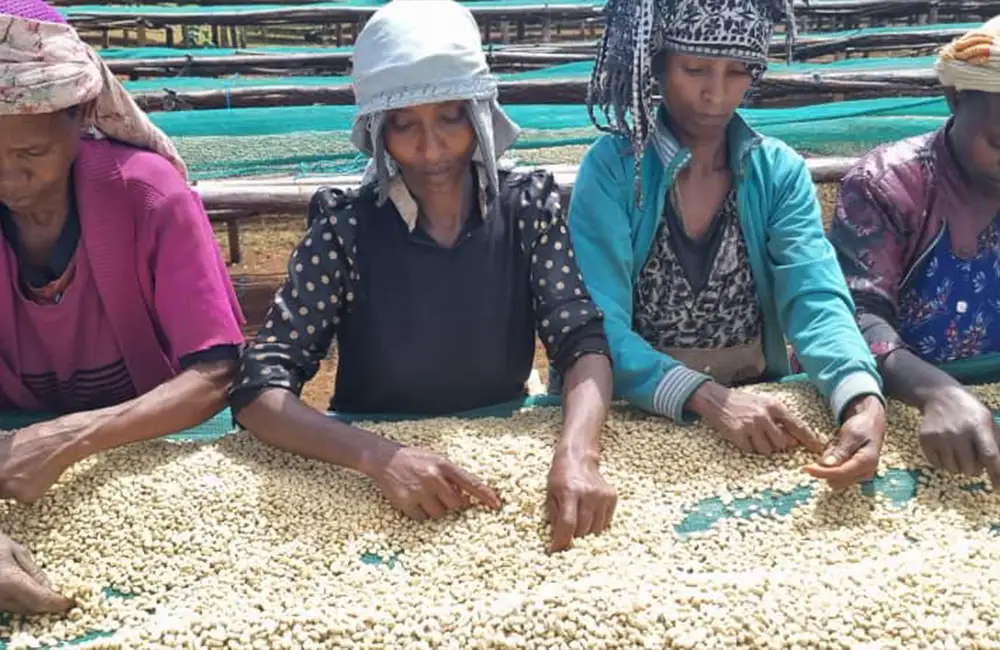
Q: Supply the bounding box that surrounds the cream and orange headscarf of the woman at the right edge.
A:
[934,16,1000,93]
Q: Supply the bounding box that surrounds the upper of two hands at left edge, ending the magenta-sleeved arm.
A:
[0,414,89,503]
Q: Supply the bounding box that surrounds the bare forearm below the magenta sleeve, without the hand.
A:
[68,361,236,459]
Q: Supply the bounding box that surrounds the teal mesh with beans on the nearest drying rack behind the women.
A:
[143,98,948,179]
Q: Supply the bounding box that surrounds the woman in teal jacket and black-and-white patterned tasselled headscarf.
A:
[570,0,885,487]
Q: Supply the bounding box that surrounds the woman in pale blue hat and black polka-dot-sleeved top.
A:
[232,0,615,550]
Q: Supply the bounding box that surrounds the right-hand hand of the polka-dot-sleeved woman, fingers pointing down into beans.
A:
[545,451,618,553]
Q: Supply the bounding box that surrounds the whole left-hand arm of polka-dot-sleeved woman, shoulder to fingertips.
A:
[232,190,500,519]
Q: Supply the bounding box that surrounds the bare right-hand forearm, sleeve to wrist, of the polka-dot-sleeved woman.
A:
[557,354,612,461]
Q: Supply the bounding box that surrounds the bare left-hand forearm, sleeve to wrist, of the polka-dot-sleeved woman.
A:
[236,388,399,476]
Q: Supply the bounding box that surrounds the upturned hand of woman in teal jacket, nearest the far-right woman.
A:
[803,395,885,490]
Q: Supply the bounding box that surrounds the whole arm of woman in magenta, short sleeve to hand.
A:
[0,184,243,501]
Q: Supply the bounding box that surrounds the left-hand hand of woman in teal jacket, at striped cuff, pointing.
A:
[689,382,823,456]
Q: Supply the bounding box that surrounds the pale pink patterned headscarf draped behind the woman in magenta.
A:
[0,0,187,178]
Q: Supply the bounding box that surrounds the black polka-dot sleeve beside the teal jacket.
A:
[505,171,611,375]
